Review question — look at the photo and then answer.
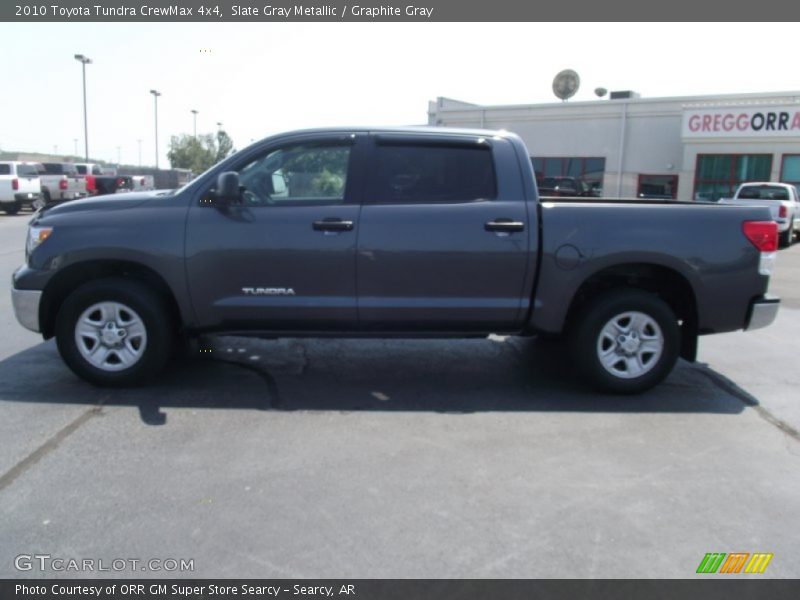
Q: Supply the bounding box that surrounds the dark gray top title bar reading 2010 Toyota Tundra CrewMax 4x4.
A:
[0,0,800,21]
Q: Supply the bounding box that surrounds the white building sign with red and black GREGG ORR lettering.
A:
[682,106,800,139]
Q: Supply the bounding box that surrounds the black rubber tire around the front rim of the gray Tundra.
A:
[55,278,175,387]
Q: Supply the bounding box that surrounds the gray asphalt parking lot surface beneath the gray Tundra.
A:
[0,210,800,578]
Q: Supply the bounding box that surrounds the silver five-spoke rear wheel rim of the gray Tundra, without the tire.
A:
[597,312,664,379]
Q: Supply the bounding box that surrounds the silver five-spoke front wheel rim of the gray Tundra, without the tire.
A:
[75,302,147,371]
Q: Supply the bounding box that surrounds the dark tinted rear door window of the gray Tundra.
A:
[372,145,497,203]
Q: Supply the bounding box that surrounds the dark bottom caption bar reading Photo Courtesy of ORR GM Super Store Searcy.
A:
[0,575,800,600]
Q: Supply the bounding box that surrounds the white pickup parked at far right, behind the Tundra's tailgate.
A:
[719,181,800,248]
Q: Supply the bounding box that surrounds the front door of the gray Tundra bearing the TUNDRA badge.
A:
[186,134,361,331]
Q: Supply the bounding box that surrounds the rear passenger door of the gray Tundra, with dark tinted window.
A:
[356,133,530,332]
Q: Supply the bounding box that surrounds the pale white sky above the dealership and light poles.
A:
[0,23,800,166]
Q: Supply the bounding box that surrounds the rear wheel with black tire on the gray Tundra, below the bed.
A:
[570,288,680,394]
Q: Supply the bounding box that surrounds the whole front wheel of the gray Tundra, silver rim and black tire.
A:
[56,278,174,387]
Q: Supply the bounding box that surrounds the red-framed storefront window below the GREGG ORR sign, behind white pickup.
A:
[694,154,772,202]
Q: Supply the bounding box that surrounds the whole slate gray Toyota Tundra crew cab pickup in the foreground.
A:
[7,128,778,393]
